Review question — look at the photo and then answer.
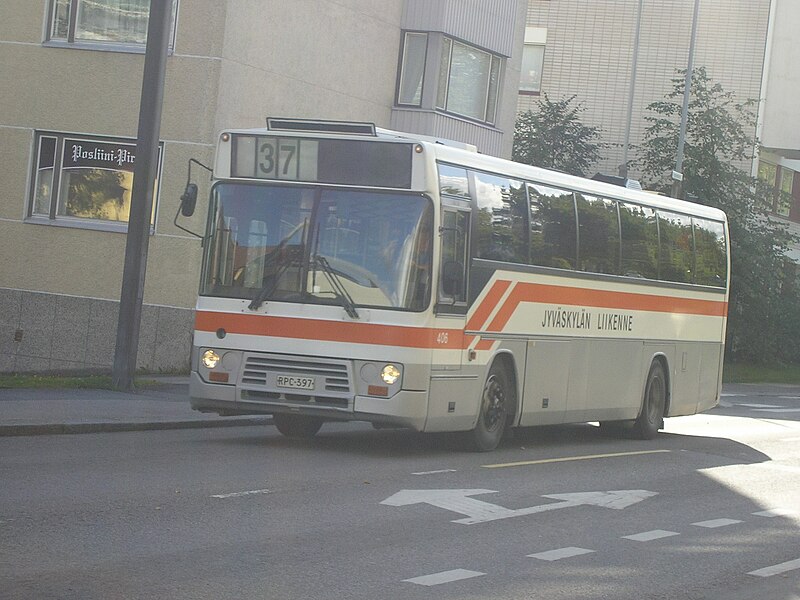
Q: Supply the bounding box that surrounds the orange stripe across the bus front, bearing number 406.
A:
[195,311,464,350]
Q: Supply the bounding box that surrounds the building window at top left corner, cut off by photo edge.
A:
[47,0,178,50]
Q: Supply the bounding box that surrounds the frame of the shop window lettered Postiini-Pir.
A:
[24,130,164,235]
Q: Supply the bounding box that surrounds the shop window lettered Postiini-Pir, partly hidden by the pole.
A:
[28,132,163,231]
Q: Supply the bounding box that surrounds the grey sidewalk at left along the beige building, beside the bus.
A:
[0,377,272,436]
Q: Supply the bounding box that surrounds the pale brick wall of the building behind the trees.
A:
[519,0,772,176]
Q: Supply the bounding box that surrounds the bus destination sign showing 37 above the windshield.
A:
[231,134,413,189]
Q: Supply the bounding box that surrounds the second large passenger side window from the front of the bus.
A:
[528,184,577,269]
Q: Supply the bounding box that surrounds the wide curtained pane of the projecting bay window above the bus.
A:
[436,38,501,123]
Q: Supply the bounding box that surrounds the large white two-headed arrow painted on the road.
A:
[381,489,657,525]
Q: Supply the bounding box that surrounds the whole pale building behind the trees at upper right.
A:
[519,0,800,261]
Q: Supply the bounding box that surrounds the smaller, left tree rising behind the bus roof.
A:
[513,94,605,175]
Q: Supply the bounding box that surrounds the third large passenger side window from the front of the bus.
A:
[575,193,619,275]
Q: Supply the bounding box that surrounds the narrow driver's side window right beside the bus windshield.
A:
[439,210,469,304]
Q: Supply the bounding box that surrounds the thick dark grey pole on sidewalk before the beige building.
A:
[111,0,172,390]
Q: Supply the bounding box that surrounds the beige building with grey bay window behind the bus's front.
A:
[0,0,527,372]
